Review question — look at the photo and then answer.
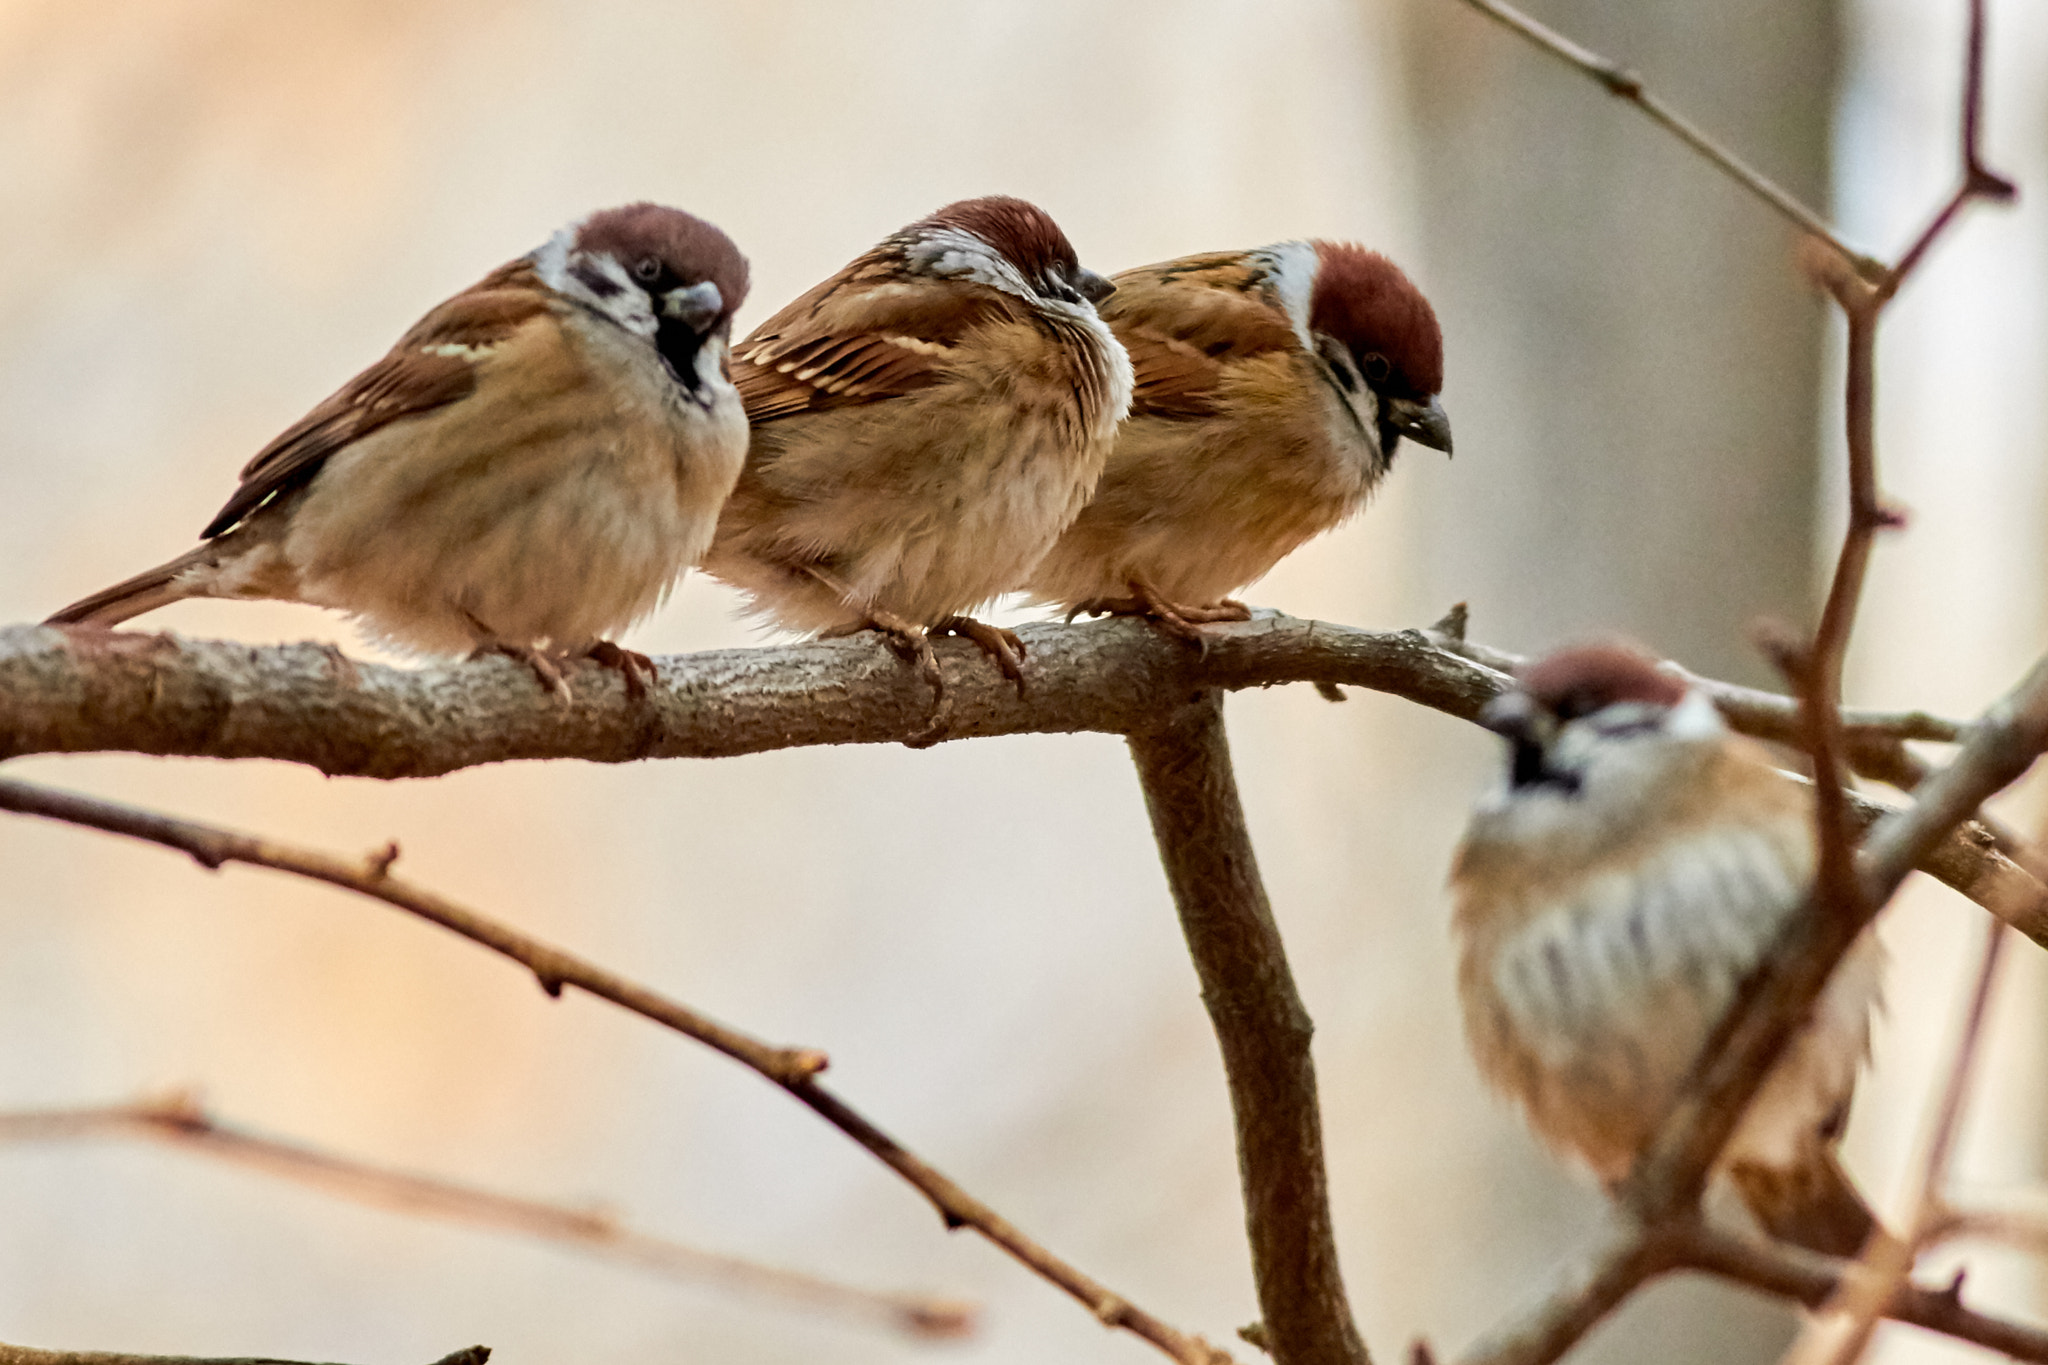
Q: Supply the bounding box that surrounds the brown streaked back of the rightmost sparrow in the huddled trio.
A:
[1102,252,1300,417]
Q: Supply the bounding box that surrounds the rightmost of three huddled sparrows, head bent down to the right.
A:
[1026,241,1450,639]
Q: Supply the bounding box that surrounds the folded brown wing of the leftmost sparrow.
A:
[199,260,547,540]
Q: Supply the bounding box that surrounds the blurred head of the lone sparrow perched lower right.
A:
[1479,643,1695,796]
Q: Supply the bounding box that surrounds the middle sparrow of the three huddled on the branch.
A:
[705,196,1130,700]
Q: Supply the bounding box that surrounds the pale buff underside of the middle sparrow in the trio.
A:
[705,323,1108,630]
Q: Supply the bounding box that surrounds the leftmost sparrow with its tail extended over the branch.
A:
[49,205,748,692]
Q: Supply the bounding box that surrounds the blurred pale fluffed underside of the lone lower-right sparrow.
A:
[1454,741,1882,1183]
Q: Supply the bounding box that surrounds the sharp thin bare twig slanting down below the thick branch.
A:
[0,778,1229,1365]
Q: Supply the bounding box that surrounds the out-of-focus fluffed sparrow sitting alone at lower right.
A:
[1450,645,1882,1257]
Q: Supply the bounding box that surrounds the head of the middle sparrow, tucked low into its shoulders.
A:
[895,194,1116,313]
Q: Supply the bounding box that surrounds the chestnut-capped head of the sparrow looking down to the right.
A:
[1282,241,1450,471]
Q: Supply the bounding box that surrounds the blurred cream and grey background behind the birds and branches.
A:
[0,0,2048,1365]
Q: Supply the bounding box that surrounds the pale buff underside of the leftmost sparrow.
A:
[195,311,745,653]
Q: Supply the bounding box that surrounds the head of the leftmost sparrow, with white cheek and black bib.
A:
[535,203,748,393]
